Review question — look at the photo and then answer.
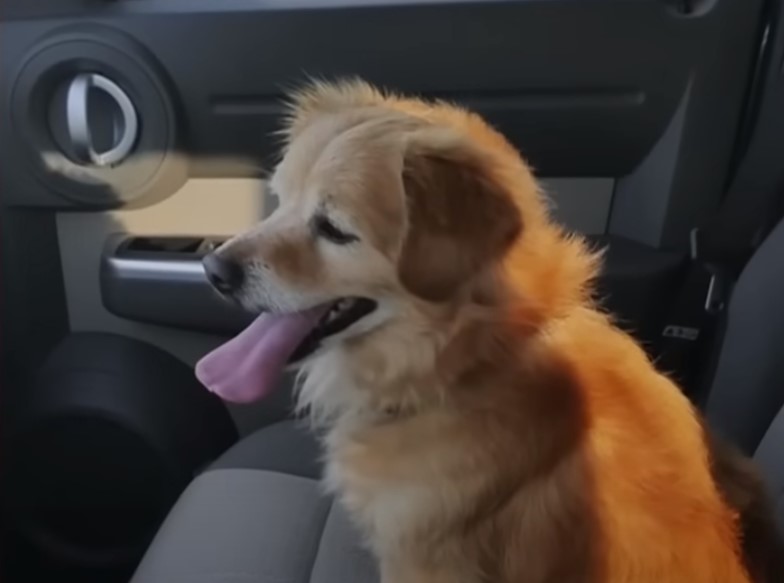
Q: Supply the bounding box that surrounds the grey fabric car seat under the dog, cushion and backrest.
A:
[132,217,784,583]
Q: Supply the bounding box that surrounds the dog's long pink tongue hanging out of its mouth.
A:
[196,306,328,403]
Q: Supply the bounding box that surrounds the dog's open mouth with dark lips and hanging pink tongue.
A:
[196,298,376,403]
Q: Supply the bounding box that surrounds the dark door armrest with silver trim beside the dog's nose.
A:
[101,235,253,334]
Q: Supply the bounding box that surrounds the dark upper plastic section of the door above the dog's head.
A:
[0,0,760,212]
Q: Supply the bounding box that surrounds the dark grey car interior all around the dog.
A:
[0,0,784,583]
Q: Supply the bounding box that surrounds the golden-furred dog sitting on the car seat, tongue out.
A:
[197,81,784,583]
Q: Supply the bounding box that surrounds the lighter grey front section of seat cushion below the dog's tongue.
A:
[131,469,378,583]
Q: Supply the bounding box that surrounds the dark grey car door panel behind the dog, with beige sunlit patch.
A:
[0,0,762,428]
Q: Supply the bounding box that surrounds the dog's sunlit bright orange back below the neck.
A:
[490,311,764,583]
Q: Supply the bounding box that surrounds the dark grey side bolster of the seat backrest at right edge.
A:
[705,220,784,454]
